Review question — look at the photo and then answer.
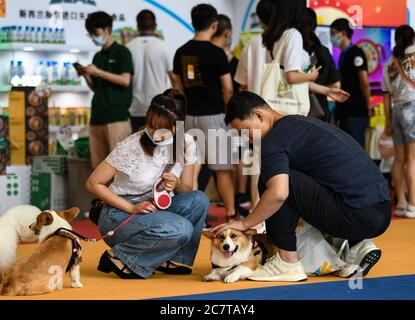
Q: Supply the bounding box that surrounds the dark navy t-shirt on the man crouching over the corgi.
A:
[259,116,389,208]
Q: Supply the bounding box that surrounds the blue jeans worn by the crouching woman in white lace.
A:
[98,191,209,278]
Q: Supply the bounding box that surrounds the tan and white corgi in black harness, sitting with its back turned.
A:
[0,208,82,296]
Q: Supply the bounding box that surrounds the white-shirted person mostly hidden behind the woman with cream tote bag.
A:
[234,0,275,207]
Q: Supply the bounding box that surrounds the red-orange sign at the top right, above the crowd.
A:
[310,0,407,27]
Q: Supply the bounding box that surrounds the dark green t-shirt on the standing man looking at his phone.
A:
[91,42,134,125]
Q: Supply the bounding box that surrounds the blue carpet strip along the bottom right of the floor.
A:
[161,275,415,300]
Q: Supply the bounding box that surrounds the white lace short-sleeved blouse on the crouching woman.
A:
[105,131,197,200]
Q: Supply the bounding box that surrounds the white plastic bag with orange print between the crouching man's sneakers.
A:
[296,220,348,276]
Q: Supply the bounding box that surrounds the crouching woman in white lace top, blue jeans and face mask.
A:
[87,90,209,279]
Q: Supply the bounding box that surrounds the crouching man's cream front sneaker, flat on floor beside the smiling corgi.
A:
[248,253,307,282]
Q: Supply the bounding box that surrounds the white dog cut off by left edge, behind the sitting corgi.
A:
[0,205,40,274]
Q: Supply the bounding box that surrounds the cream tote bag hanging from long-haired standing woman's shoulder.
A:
[261,34,310,116]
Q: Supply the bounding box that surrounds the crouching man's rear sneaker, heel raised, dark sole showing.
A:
[336,240,382,278]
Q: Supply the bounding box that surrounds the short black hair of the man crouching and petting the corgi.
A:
[225,91,271,124]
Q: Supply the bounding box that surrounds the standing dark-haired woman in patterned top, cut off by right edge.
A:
[382,25,415,218]
